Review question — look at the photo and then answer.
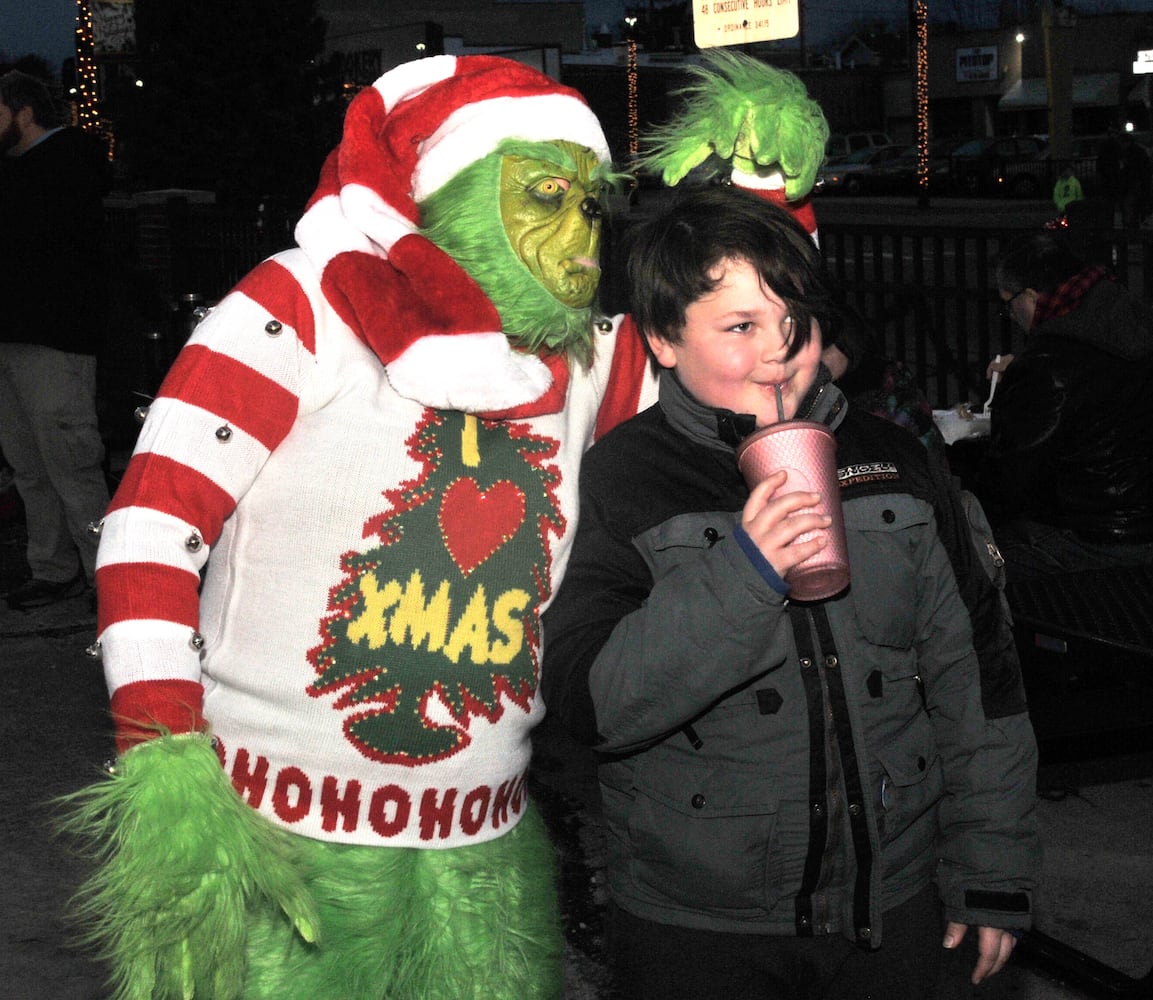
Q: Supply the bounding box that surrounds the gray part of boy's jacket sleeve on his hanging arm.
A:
[918,519,1040,928]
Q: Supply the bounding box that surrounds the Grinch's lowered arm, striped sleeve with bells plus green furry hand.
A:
[66,252,317,997]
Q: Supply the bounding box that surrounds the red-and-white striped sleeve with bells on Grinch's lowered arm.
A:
[96,261,315,750]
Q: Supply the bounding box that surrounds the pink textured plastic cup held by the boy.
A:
[737,420,849,601]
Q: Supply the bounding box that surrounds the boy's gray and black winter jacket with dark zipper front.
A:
[542,373,1040,947]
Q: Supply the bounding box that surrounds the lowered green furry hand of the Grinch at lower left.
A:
[61,735,316,1000]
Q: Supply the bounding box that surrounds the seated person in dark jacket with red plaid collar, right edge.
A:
[977,232,1153,581]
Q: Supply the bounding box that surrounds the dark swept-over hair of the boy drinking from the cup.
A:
[627,185,837,358]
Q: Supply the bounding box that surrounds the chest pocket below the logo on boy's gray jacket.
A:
[844,494,928,649]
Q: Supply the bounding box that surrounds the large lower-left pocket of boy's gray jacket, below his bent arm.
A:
[628,760,781,911]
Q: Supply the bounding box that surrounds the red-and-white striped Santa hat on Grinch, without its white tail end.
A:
[296,55,611,412]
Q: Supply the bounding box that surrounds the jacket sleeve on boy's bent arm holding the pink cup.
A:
[542,448,791,752]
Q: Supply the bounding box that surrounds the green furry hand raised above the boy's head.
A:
[643,50,829,201]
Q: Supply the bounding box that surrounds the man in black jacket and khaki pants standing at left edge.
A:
[0,70,111,610]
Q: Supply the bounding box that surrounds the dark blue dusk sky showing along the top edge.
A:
[0,0,1153,68]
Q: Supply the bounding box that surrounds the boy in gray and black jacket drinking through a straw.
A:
[542,188,1039,1000]
